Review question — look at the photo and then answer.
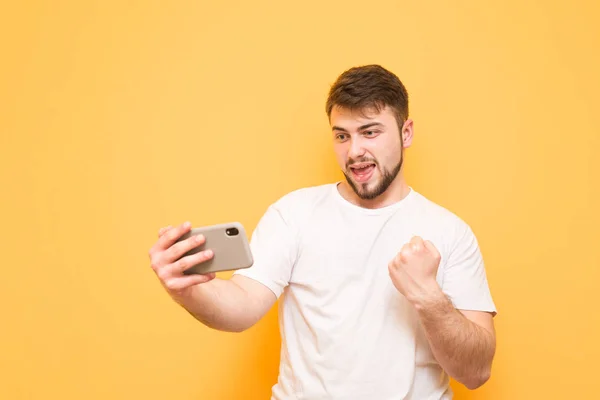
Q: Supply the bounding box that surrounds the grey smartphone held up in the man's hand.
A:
[177,222,254,275]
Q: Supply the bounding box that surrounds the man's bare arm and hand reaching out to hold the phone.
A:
[149,223,276,332]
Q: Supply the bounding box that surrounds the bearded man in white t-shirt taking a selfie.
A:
[150,65,496,400]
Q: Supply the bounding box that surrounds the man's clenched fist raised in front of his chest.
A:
[388,236,441,306]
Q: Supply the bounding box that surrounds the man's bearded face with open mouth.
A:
[330,107,410,200]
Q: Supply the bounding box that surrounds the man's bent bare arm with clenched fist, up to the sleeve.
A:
[389,237,496,389]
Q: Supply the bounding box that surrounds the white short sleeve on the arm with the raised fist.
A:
[442,221,497,315]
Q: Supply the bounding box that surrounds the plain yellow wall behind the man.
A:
[0,0,600,400]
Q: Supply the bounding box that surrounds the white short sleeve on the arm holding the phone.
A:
[234,205,297,298]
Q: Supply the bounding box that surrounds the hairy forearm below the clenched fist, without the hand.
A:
[416,290,496,389]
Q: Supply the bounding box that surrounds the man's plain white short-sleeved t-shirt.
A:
[235,184,496,400]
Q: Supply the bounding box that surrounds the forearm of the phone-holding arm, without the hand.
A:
[174,278,260,332]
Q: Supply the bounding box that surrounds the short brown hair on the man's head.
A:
[325,64,408,129]
